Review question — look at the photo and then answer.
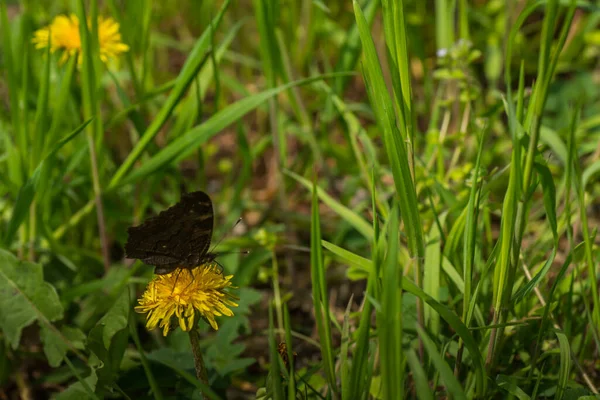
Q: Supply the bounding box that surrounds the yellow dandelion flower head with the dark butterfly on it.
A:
[135,263,237,336]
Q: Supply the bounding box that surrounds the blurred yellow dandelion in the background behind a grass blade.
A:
[32,14,129,64]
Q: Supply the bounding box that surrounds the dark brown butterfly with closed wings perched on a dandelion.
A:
[125,191,217,275]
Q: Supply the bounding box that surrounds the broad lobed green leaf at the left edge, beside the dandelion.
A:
[0,249,66,353]
